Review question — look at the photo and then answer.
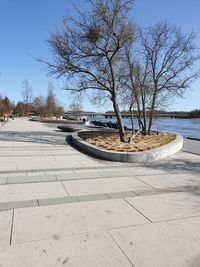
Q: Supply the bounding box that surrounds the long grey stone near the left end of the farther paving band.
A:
[7,175,57,184]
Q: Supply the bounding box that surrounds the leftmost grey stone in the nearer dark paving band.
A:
[0,200,38,211]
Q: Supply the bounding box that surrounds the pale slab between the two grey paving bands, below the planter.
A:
[63,177,152,196]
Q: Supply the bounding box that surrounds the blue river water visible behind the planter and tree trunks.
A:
[93,116,200,139]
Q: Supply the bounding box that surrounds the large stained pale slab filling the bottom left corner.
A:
[0,232,132,267]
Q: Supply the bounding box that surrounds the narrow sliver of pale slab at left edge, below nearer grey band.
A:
[0,210,13,246]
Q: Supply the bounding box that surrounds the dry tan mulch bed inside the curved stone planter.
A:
[78,131,176,152]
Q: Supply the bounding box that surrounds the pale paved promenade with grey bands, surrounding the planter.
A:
[0,118,200,267]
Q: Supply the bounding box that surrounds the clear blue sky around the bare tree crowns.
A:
[0,0,200,110]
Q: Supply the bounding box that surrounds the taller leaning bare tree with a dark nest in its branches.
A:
[39,0,135,141]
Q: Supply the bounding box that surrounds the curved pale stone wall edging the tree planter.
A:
[72,133,183,163]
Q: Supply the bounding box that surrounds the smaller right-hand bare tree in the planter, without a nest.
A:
[126,23,199,133]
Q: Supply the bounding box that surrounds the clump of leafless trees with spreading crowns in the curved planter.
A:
[38,0,199,142]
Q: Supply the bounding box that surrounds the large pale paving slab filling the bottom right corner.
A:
[109,217,200,267]
